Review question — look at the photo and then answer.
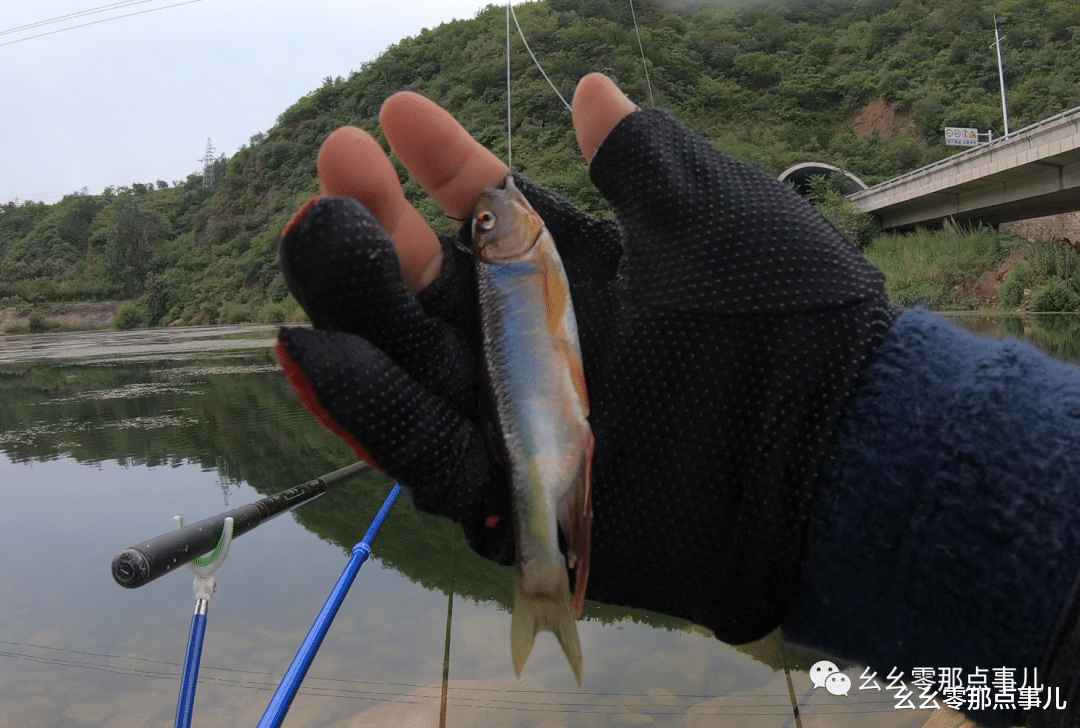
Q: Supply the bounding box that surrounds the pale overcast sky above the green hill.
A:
[0,0,514,203]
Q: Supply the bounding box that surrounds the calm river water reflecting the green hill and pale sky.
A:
[0,316,1080,728]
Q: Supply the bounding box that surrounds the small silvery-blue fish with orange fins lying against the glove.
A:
[472,175,594,685]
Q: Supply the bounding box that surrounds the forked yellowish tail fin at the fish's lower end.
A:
[510,569,581,685]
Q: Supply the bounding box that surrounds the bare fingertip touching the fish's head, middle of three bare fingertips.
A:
[379,91,510,218]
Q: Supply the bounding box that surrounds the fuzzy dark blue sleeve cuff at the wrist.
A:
[784,309,1080,726]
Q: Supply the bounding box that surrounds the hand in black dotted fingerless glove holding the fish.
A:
[279,75,895,644]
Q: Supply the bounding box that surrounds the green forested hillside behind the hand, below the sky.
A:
[0,0,1080,325]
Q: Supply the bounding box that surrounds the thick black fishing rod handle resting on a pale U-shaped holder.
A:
[112,462,372,589]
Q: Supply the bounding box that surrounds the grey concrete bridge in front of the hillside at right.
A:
[849,107,1080,230]
